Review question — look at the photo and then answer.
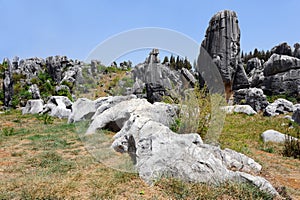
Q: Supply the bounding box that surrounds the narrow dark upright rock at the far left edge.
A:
[3,58,14,107]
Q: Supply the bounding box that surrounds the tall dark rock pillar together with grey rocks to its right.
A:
[196,10,300,119]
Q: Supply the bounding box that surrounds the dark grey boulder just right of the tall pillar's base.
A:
[234,88,269,111]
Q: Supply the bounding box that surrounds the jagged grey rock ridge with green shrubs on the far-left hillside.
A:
[3,56,88,107]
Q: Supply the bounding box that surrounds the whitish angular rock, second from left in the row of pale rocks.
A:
[42,96,73,118]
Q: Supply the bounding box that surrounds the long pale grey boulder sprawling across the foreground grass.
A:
[79,99,277,195]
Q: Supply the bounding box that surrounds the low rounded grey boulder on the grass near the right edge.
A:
[264,99,294,116]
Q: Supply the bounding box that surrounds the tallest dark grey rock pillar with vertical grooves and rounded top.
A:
[197,10,249,100]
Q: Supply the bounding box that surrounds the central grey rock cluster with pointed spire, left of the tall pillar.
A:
[131,49,197,103]
